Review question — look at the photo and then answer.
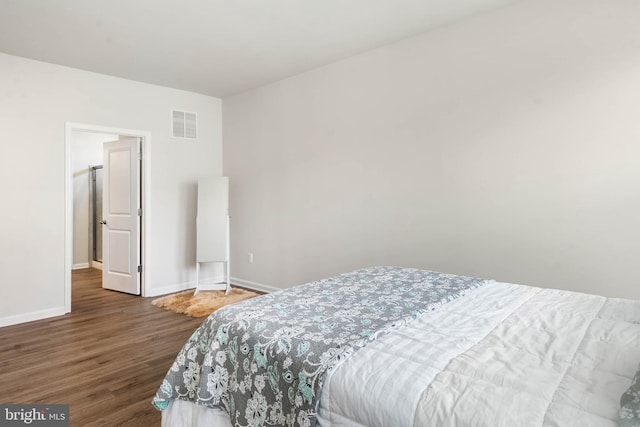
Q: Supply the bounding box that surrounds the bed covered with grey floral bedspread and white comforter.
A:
[153,267,640,427]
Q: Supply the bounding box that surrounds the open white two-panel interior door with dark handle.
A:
[102,138,141,295]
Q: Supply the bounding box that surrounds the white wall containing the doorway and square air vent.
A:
[0,54,222,326]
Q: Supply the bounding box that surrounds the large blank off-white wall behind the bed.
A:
[223,0,640,298]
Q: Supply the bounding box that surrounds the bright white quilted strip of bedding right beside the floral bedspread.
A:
[319,283,539,427]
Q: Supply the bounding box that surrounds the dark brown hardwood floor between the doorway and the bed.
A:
[0,269,203,427]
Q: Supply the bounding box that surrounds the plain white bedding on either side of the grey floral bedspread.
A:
[163,283,640,427]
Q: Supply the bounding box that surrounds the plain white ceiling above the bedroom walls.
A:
[0,0,515,98]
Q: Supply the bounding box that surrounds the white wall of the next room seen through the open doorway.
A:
[71,131,119,268]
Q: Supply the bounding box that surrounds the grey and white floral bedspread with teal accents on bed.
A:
[153,267,485,427]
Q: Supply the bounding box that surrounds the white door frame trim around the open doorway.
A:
[64,122,151,313]
